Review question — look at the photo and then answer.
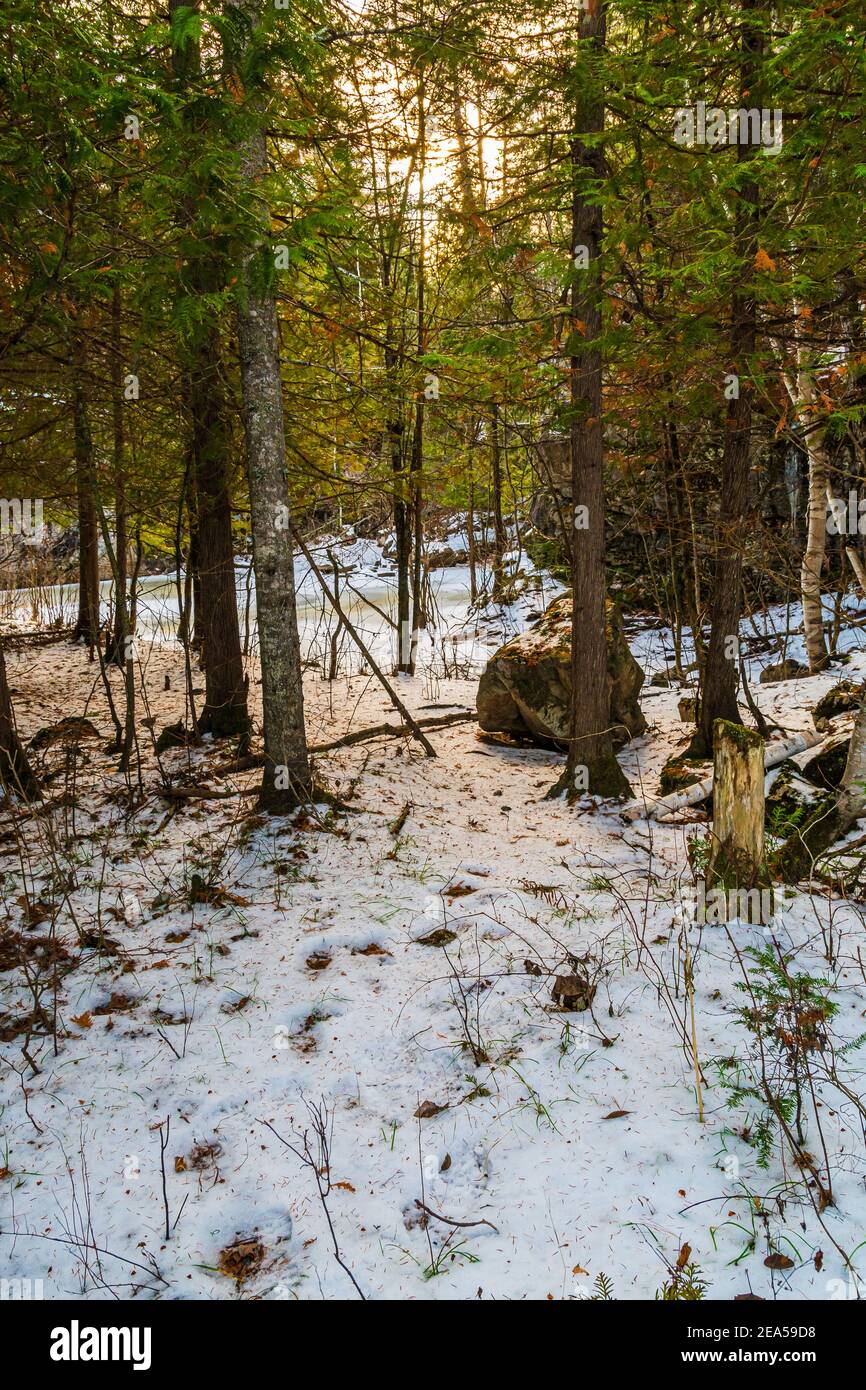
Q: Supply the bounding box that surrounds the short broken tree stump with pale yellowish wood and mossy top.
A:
[701,719,773,926]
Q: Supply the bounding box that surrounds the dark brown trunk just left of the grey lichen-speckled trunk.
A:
[170,0,250,737]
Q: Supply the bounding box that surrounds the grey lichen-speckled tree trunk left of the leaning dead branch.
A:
[238,3,313,810]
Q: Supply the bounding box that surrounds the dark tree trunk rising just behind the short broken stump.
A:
[689,0,763,758]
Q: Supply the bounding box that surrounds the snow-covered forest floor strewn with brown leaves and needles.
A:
[0,567,866,1300]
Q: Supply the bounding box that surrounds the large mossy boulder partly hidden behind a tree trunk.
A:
[475,595,646,748]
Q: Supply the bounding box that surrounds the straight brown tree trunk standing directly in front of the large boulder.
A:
[552,4,630,796]
